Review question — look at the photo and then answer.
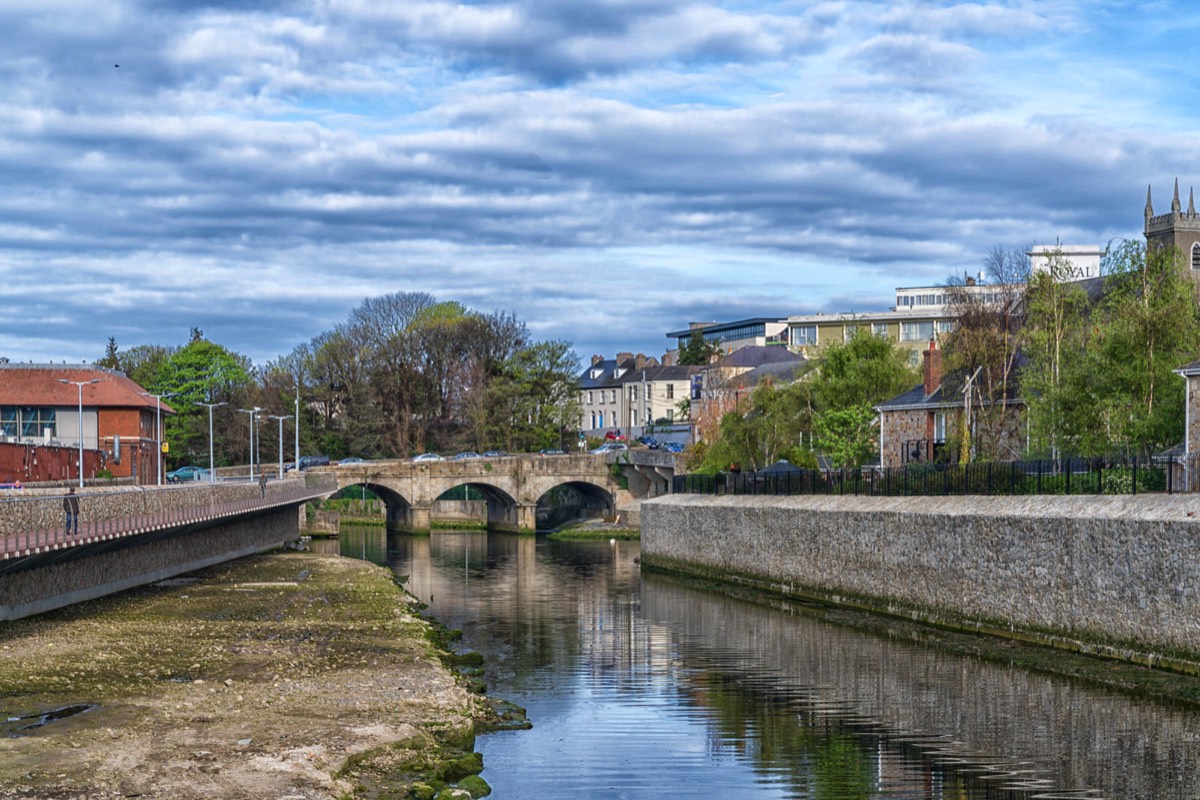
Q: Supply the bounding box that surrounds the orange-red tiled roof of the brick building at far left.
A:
[0,363,175,414]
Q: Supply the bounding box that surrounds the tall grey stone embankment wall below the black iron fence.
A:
[642,494,1200,673]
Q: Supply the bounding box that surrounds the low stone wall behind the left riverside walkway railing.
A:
[0,477,304,536]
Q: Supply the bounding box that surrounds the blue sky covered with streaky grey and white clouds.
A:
[0,0,1200,365]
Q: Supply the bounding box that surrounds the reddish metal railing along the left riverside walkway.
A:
[0,481,336,560]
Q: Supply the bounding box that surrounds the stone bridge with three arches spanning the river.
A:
[319,453,628,533]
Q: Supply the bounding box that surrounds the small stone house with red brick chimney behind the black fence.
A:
[875,339,1025,467]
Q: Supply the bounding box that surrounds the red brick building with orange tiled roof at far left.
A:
[0,363,175,483]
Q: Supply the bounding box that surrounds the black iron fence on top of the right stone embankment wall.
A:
[671,456,1200,497]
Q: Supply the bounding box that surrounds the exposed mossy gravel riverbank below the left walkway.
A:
[0,553,494,800]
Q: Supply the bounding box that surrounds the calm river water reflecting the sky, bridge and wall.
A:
[322,527,1200,800]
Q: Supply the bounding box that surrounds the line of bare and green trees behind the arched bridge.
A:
[97,293,580,465]
